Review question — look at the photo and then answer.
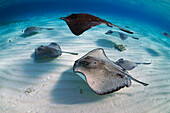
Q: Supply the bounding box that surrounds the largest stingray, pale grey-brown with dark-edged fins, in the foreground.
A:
[73,48,148,95]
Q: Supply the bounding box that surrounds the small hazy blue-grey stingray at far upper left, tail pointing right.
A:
[22,27,54,37]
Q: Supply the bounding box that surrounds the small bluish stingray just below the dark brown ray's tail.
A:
[105,30,139,40]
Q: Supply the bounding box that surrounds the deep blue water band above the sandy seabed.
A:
[0,0,170,32]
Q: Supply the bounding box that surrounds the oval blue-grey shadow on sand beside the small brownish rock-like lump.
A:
[96,39,116,48]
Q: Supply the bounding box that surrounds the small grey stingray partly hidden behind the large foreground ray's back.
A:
[116,58,151,70]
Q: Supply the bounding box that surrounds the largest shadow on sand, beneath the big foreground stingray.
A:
[51,68,132,105]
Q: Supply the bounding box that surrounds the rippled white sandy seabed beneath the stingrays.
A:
[0,14,170,113]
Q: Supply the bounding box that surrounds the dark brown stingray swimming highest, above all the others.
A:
[61,13,133,36]
